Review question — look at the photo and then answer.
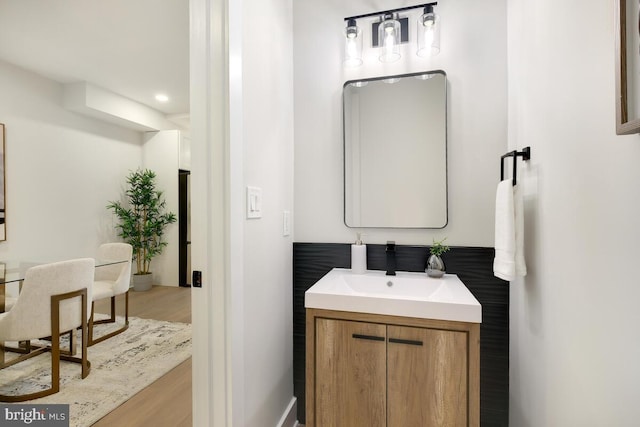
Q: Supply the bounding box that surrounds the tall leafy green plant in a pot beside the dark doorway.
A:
[107,169,177,291]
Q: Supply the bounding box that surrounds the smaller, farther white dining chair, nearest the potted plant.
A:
[89,243,133,346]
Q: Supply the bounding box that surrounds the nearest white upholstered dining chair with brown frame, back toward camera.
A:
[0,258,95,402]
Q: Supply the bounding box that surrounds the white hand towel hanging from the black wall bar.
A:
[493,179,527,281]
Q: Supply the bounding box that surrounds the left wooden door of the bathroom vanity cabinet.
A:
[315,319,386,427]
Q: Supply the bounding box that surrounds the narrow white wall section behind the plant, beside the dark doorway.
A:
[141,130,181,286]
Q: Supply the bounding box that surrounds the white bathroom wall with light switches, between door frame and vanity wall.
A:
[241,0,293,426]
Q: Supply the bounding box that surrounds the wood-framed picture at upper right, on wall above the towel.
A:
[615,0,640,135]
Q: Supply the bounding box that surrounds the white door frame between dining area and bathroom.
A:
[189,0,245,427]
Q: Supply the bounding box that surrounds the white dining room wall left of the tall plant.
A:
[0,61,141,260]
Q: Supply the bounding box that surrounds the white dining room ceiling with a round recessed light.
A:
[0,0,189,115]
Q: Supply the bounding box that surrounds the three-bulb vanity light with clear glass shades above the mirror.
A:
[344,2,440,67]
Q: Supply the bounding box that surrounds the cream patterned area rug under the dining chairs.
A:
[0,317,191,427]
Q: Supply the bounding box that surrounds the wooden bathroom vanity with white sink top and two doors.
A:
[305,269,482,427]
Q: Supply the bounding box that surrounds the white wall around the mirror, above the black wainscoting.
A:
[294,0,507,246]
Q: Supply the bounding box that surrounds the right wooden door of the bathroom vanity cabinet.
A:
[387,326,468,427]
